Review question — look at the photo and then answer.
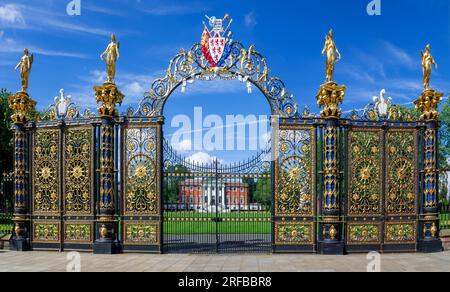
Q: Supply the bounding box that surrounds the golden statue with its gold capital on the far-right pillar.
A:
[414,44,444,121]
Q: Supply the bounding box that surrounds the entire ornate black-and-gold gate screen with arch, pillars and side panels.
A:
[10,16,443,254]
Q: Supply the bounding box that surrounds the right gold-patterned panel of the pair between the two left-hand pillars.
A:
[62,125,95,248]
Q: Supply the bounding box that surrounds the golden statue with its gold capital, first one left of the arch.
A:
[94,34,125,117]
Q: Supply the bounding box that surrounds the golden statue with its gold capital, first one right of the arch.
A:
[317,29,346,119]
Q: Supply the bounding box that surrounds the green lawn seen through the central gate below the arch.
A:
[164,212,272,235]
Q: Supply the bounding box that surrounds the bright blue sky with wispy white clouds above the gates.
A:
[0,0,450,160]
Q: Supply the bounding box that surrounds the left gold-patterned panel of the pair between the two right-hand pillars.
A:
[346,128,384,249]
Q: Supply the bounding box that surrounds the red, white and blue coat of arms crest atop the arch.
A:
[201,14,233,68]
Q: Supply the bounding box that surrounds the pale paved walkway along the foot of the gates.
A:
[0,251,450,272]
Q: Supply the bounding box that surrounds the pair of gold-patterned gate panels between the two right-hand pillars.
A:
[346,123,419,252]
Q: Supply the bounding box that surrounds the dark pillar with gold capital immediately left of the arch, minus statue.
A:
[94,82,124,254]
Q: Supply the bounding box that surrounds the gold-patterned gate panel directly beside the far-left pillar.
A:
[31,128,61,247]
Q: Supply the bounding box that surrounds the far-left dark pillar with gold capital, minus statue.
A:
[9,92,36,251]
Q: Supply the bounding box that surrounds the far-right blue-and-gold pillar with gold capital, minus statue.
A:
[415,89,444,252]
